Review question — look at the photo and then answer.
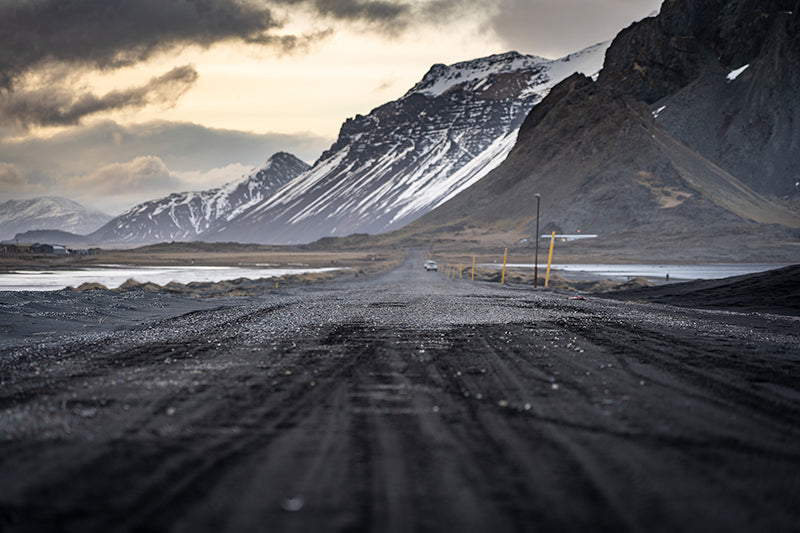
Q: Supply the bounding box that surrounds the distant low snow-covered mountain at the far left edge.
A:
[0,196,111,239]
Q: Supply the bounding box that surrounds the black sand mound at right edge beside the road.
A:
[602,265,800,316]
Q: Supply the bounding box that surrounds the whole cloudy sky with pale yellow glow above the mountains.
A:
[0,0,660,215]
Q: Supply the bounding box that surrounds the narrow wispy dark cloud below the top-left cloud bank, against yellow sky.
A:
[0,65,197,128]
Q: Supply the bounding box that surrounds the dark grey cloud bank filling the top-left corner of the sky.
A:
[0,0,280,88]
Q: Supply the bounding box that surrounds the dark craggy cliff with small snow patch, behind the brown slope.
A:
[598,0,800,196]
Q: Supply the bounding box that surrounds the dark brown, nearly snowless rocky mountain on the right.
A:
[404,0,800,255]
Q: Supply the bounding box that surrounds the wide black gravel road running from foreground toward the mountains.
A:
[0,253,800,532]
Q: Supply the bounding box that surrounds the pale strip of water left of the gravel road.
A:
[0,265,339,291]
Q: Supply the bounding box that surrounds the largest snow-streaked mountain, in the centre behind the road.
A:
[201,43,608,244]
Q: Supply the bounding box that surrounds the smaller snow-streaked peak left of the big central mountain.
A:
[89,152,309,244]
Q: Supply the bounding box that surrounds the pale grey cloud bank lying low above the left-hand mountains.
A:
[0,121,333,214]
